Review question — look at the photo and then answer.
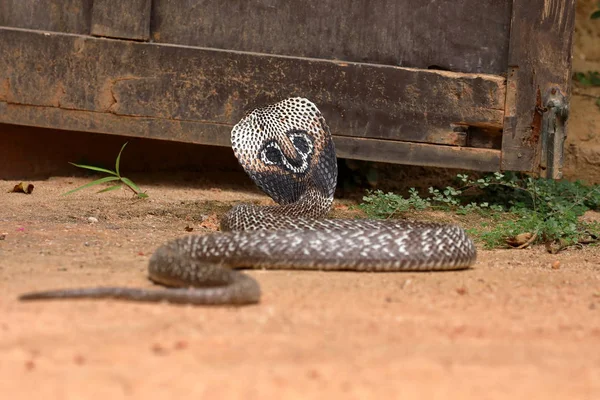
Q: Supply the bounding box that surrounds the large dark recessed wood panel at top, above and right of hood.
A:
[152,0,510,74]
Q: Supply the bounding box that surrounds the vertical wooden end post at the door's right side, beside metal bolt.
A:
[502,0,575,178]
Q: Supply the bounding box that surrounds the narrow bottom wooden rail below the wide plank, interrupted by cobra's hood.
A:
[0,102,500,171]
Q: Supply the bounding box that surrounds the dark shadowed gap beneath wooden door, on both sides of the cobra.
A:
[0,124,466,199]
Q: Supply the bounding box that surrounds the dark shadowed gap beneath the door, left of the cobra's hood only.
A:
[0,124,242,179]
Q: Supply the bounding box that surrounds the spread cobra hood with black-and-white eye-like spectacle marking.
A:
[231,97,337,204]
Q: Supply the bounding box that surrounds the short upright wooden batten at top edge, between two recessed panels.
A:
[92,0,152,40]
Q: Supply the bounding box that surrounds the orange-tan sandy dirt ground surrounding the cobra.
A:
[0,177,600,400]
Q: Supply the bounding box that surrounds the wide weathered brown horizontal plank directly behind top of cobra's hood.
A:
[0,28,505,147]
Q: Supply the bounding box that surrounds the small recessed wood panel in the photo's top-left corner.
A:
[0,0,94,34]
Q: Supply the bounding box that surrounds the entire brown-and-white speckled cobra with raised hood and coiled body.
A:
[21,98,476,305]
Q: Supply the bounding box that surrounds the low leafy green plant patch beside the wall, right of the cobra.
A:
[359,172,600,248]
